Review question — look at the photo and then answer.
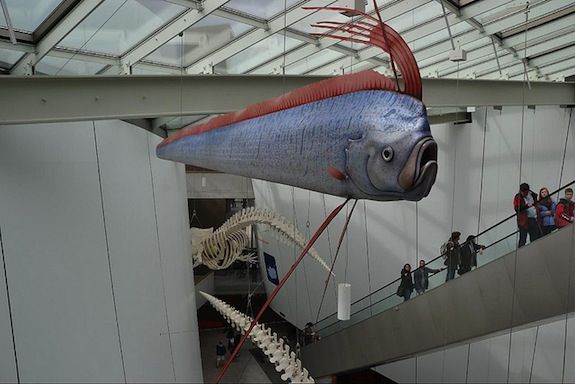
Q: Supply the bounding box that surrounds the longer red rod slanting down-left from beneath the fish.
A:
[216,199,349,384]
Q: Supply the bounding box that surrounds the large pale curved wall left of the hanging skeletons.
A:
[0,121,202,382]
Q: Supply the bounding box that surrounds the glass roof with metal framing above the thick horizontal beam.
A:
[0,0,575,81]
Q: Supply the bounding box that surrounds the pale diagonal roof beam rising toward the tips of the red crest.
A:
[186,0,334,74]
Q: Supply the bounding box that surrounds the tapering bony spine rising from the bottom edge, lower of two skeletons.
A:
[200,291,315,383]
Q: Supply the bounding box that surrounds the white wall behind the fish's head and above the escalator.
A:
[254,106,575,327]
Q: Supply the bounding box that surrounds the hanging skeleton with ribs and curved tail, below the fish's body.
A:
[191,207,330,271]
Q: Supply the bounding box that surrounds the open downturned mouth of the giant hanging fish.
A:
[398,136,437,201]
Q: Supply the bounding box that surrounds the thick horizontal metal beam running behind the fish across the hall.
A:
[0,75,575,124]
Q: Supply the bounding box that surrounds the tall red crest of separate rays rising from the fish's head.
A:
[303,5,422,100]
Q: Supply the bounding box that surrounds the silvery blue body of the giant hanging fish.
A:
[157,90,431,200]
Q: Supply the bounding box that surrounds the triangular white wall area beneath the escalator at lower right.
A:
[374,316,575,383]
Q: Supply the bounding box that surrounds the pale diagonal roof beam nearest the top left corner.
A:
[11,0,104,75]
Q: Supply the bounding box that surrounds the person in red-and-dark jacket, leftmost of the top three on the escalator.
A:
[513,183,541,247]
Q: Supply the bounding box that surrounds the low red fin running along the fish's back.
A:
[160,71,396,145]
